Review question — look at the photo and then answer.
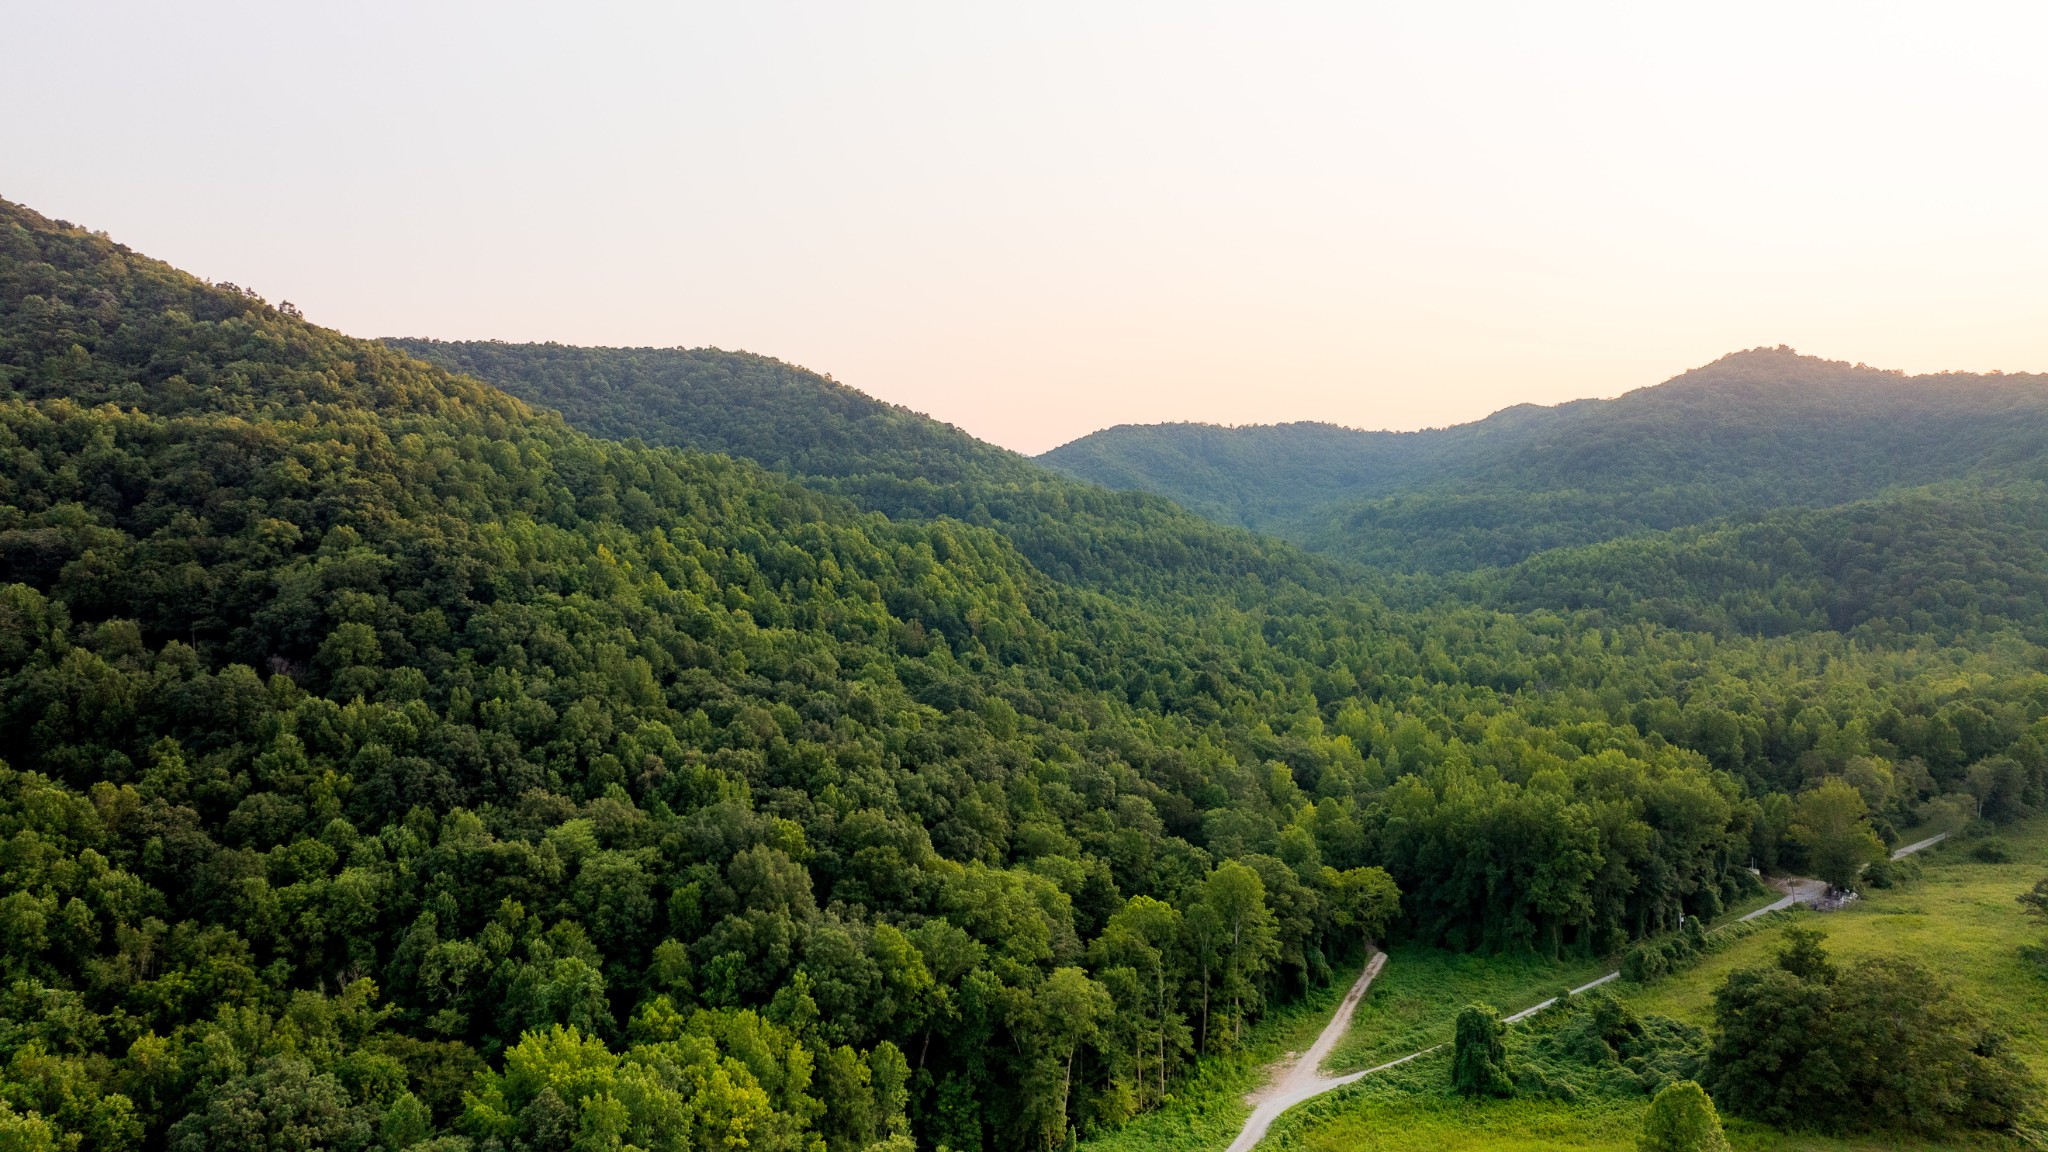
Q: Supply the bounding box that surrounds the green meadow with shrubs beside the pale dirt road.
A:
[1262,818,2048,1152]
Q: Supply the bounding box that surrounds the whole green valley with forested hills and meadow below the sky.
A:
[0,201,2048,1152]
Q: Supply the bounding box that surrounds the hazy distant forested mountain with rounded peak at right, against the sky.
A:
[1040,348,2048,572]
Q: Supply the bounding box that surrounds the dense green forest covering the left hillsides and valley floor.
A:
[0,203,2048,1152]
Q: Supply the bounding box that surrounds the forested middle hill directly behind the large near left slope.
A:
[385,340,1354,603]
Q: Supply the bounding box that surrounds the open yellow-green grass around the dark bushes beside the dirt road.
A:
[1261,820,2048,1152]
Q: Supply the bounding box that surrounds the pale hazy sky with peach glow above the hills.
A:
[0,0,2048,451]
